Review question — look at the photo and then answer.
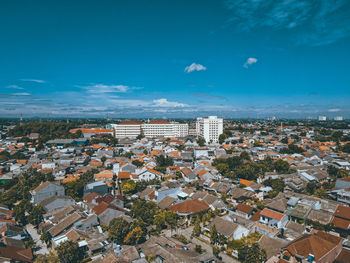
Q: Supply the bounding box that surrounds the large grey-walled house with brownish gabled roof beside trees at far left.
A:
[31,182,64,204]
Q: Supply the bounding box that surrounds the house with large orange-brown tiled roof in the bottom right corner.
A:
[281,231,343,263]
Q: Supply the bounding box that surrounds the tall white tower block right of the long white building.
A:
[196,116,224,142]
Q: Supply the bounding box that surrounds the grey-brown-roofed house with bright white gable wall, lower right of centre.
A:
[206,216,249,240]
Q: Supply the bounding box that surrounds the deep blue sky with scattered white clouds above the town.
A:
[0,0,350,118]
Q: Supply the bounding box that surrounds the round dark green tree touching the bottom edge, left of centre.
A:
[56,241,84,263]
